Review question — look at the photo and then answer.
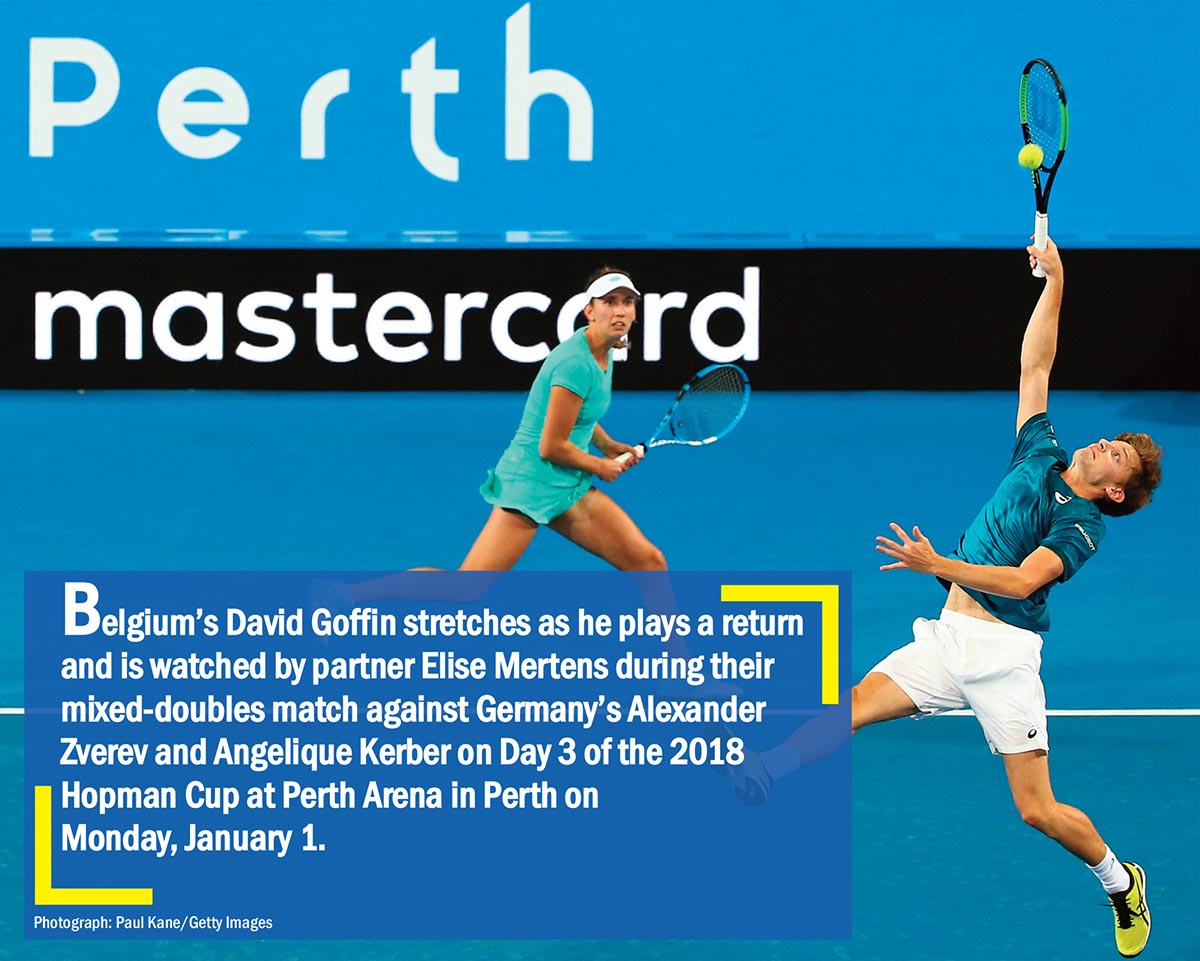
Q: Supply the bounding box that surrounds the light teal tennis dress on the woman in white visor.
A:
[479,329,612,524]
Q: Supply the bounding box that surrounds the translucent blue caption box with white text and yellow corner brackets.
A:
[25,572,851,939]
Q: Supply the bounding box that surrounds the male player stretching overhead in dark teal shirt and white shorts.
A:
[726,241,1162,957]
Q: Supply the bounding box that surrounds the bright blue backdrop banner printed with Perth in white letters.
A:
[0,0,1200,247]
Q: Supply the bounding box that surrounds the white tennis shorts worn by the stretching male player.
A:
[872,611,1050,755]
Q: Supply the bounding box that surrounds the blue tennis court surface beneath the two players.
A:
[0,391,1200,961]
